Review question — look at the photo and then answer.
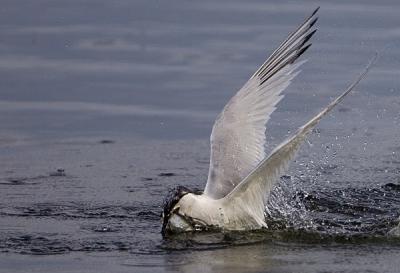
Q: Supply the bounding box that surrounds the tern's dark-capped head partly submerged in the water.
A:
[161,186,200,237]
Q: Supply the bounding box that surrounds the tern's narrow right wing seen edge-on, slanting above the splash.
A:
[222,54,378,215]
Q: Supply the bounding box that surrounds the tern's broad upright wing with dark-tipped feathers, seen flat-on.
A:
[204,8,318,199]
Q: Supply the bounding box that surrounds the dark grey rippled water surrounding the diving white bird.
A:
[0,0,400,272]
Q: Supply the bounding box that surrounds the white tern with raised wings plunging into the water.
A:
[161,8,376,236]
